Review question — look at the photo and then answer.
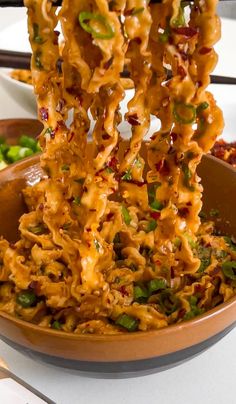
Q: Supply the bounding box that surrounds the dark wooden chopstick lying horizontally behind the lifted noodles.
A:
[0,50,236,84]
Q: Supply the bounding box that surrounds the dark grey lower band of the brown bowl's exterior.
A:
[0,322,236,379]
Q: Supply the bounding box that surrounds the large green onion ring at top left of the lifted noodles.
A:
[78,11,115,39]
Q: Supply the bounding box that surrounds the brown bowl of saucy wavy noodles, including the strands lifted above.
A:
[0,0,236,376]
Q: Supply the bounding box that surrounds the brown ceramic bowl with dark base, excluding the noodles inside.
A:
[0,156,236,377]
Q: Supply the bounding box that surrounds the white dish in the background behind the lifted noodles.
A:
[0,18,236,141]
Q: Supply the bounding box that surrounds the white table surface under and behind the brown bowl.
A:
[0,9,236,404]
